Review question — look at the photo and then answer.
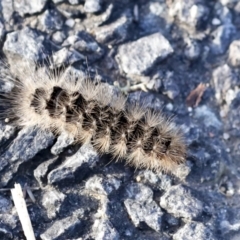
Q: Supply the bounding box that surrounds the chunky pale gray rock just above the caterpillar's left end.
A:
[3,27,51,64]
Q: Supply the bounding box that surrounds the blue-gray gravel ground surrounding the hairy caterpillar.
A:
[0,0,240,240]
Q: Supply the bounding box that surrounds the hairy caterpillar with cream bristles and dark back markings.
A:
[0,59,186,172]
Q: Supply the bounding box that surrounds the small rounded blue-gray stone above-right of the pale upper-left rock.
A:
[40,9,64,32]
